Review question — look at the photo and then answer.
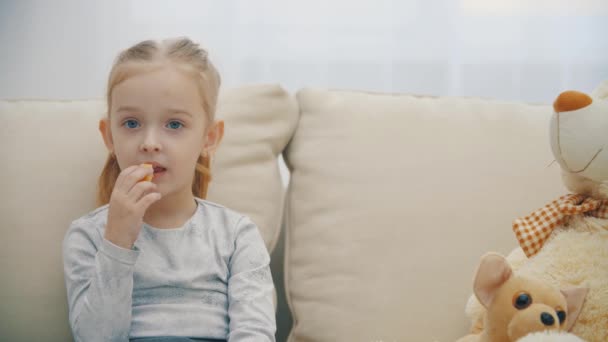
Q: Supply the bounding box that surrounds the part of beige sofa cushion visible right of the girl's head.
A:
[207,85,299,250]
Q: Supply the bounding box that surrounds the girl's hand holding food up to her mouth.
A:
[104,165,161,249]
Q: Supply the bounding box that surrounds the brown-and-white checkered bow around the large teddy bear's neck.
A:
[513,194,608,257]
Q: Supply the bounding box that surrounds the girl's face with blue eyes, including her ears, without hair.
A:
[100,66,223,196]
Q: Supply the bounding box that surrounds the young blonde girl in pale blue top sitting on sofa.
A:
[63,39,275,342]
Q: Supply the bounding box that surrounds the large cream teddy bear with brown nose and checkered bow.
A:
[466,81,608,342]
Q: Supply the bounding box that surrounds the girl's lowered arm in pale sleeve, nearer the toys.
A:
[228,217,276,342]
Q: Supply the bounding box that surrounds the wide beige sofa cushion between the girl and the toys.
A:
[285,89,566,342]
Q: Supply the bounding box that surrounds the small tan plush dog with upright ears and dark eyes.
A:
[458,253,587,342]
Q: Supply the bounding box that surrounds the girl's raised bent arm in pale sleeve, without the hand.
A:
[63,220,139,342]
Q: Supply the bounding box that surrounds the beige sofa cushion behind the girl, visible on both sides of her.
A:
[0,85,298,341]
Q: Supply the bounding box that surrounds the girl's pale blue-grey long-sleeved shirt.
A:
[63,198,276,342]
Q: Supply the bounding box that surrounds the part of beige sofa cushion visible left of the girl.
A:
[0,101,105,341]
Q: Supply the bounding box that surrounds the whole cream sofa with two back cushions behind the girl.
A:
[0,85,588,342]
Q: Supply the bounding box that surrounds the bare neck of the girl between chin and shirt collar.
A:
[143,189,197,229]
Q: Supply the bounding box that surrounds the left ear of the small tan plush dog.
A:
[473,253,513,308]
